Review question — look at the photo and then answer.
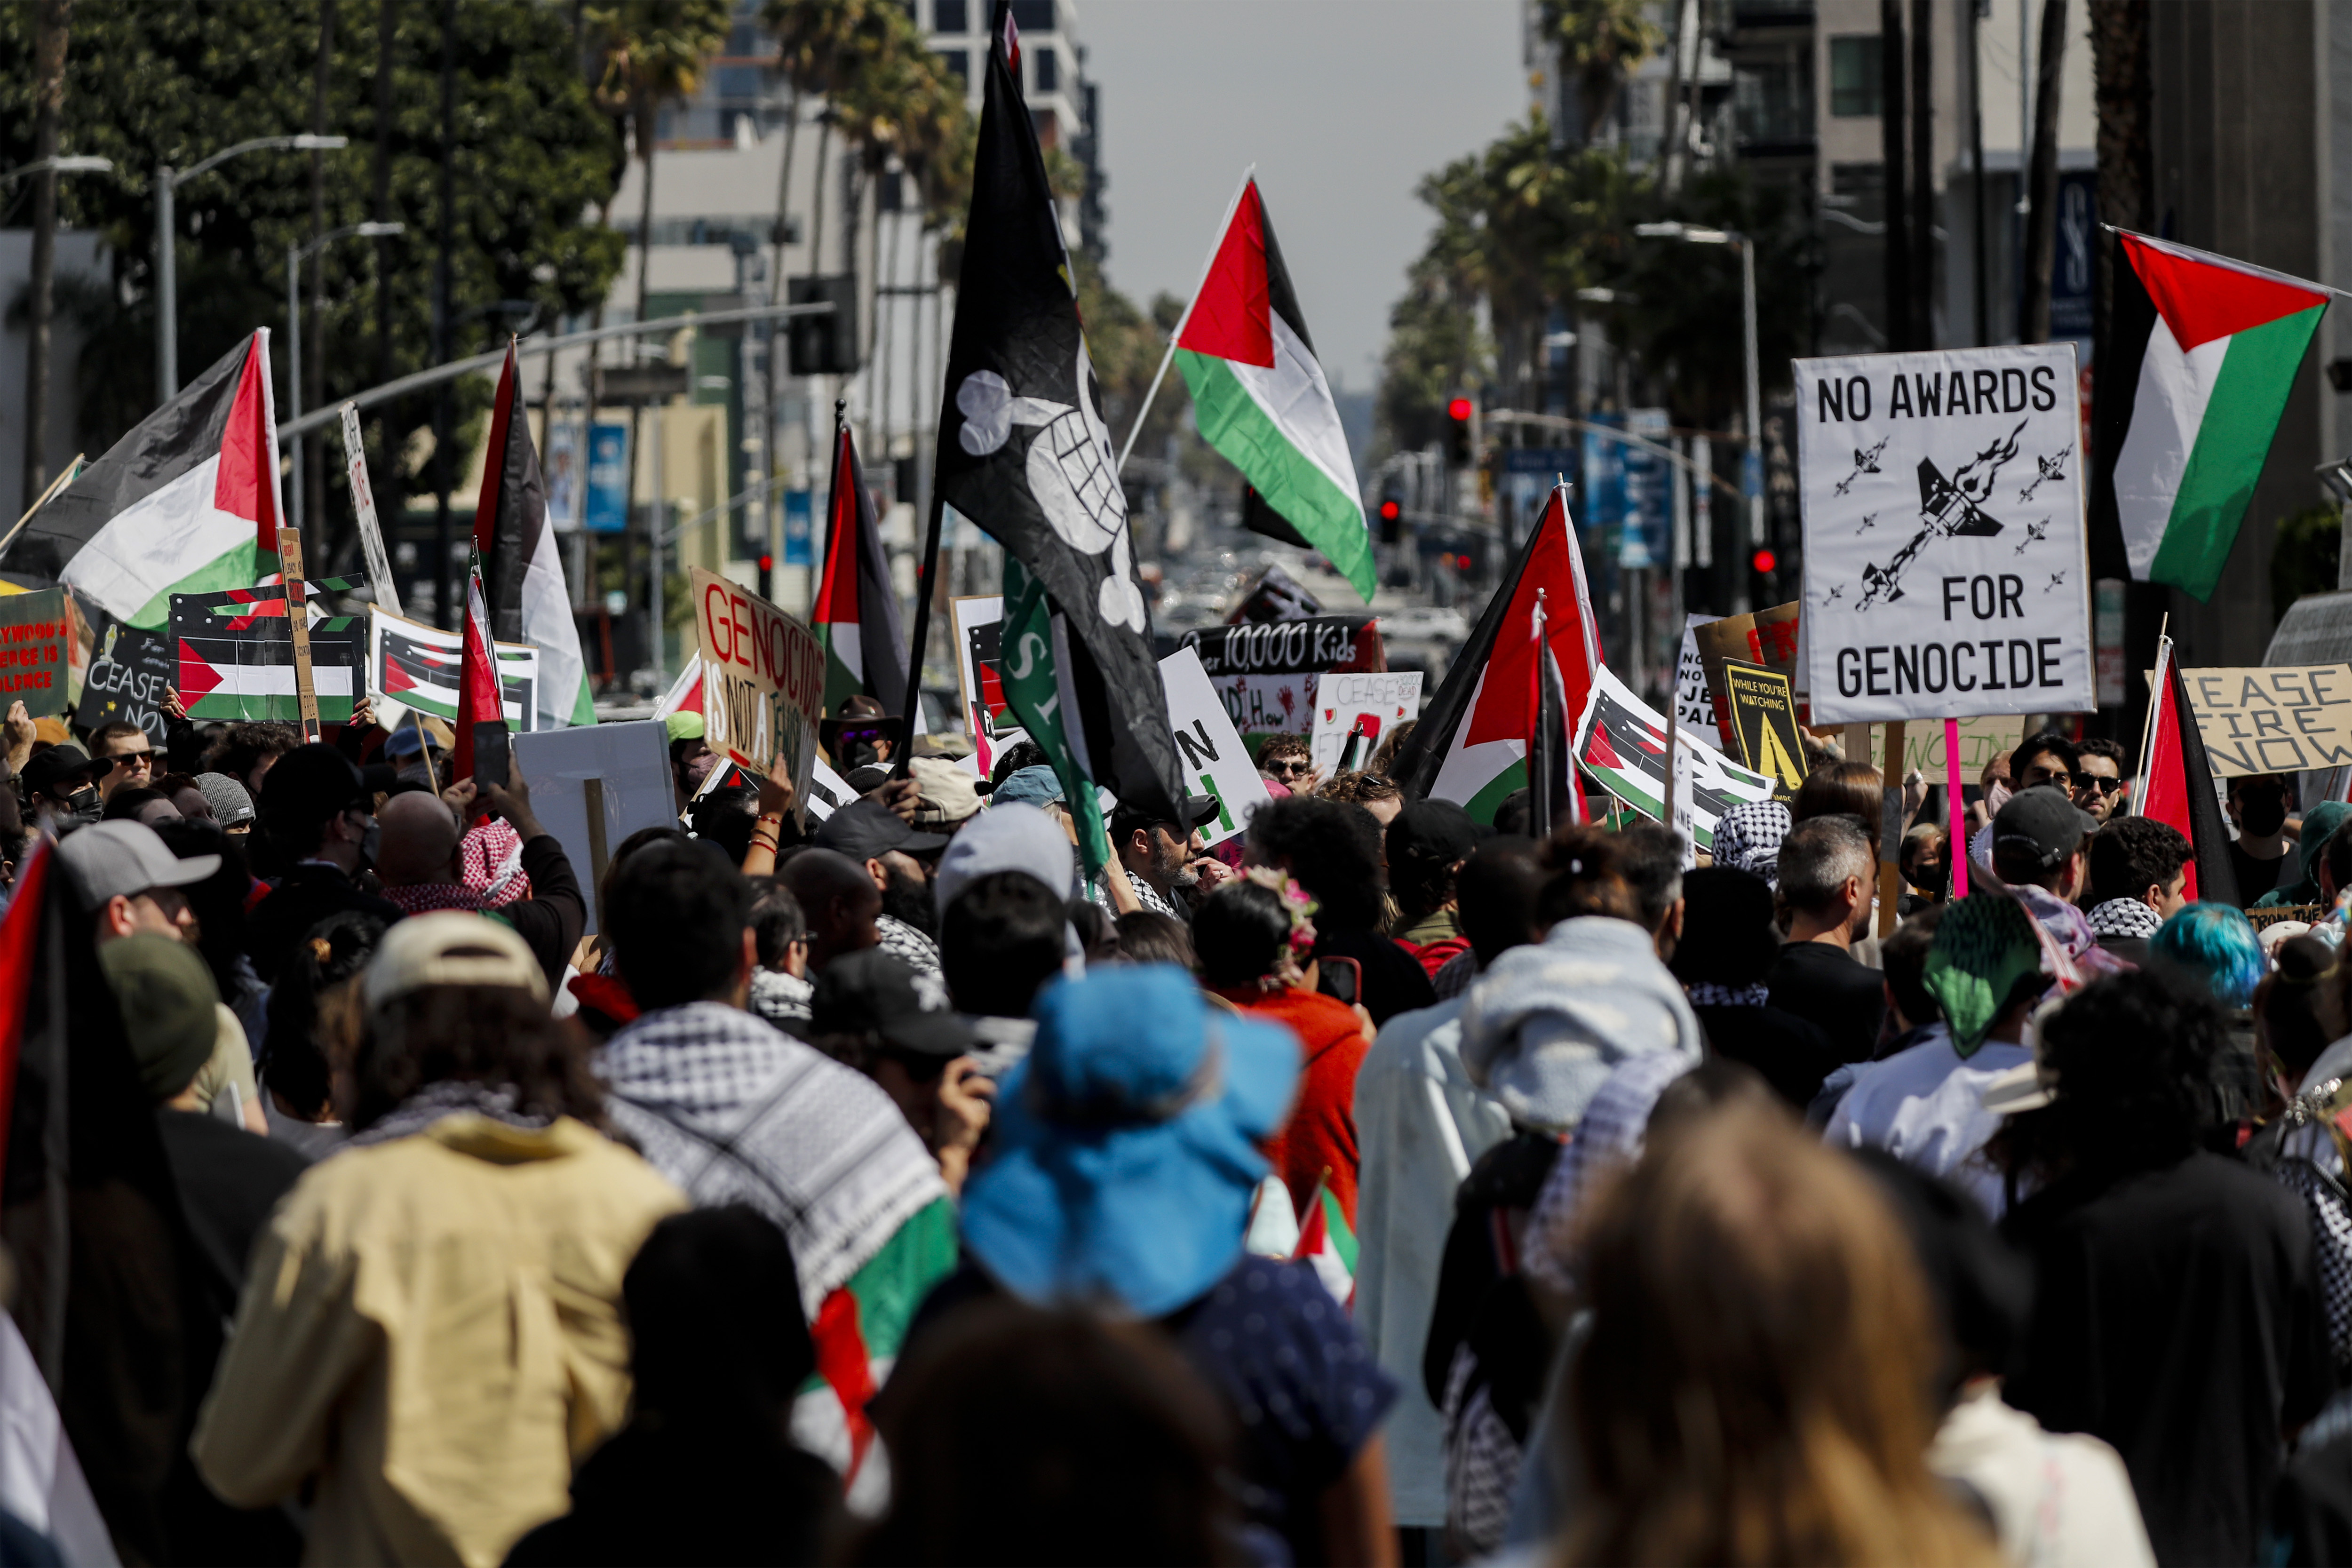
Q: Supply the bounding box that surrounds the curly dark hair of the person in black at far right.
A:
[1990,971,2227,1189]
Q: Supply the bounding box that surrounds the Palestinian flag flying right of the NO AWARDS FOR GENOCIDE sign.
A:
[2091,231,2328,599]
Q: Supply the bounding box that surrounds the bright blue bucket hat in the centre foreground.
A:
[964,964,1298,1319]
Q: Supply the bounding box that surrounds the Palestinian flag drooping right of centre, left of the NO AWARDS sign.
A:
[1395,484,1602,823]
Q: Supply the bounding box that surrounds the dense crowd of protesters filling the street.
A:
[14,677,2352,1568]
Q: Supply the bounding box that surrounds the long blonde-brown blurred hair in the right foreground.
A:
[1566,1105,1999,1568]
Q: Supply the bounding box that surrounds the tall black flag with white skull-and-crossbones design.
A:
[917,0,1183,820]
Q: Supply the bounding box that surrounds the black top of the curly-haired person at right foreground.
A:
[2004,1152,2336,1563]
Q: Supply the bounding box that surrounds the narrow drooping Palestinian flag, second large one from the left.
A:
[473,343,595,729]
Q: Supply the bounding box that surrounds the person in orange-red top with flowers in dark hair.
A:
[1192,868,1371,1229]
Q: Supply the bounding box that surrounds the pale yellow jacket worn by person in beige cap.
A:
[193,1114,687,1568]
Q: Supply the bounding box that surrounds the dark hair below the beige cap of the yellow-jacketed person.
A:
[341,985,604,1131]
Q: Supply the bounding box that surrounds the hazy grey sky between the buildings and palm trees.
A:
[1073,0,1526,390]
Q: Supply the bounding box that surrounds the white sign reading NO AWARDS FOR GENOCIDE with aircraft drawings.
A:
[1795,343,2096,724]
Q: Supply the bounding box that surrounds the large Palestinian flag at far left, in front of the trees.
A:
[30,327,285,630]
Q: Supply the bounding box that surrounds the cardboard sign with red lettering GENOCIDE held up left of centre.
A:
[689,566,826,820]
